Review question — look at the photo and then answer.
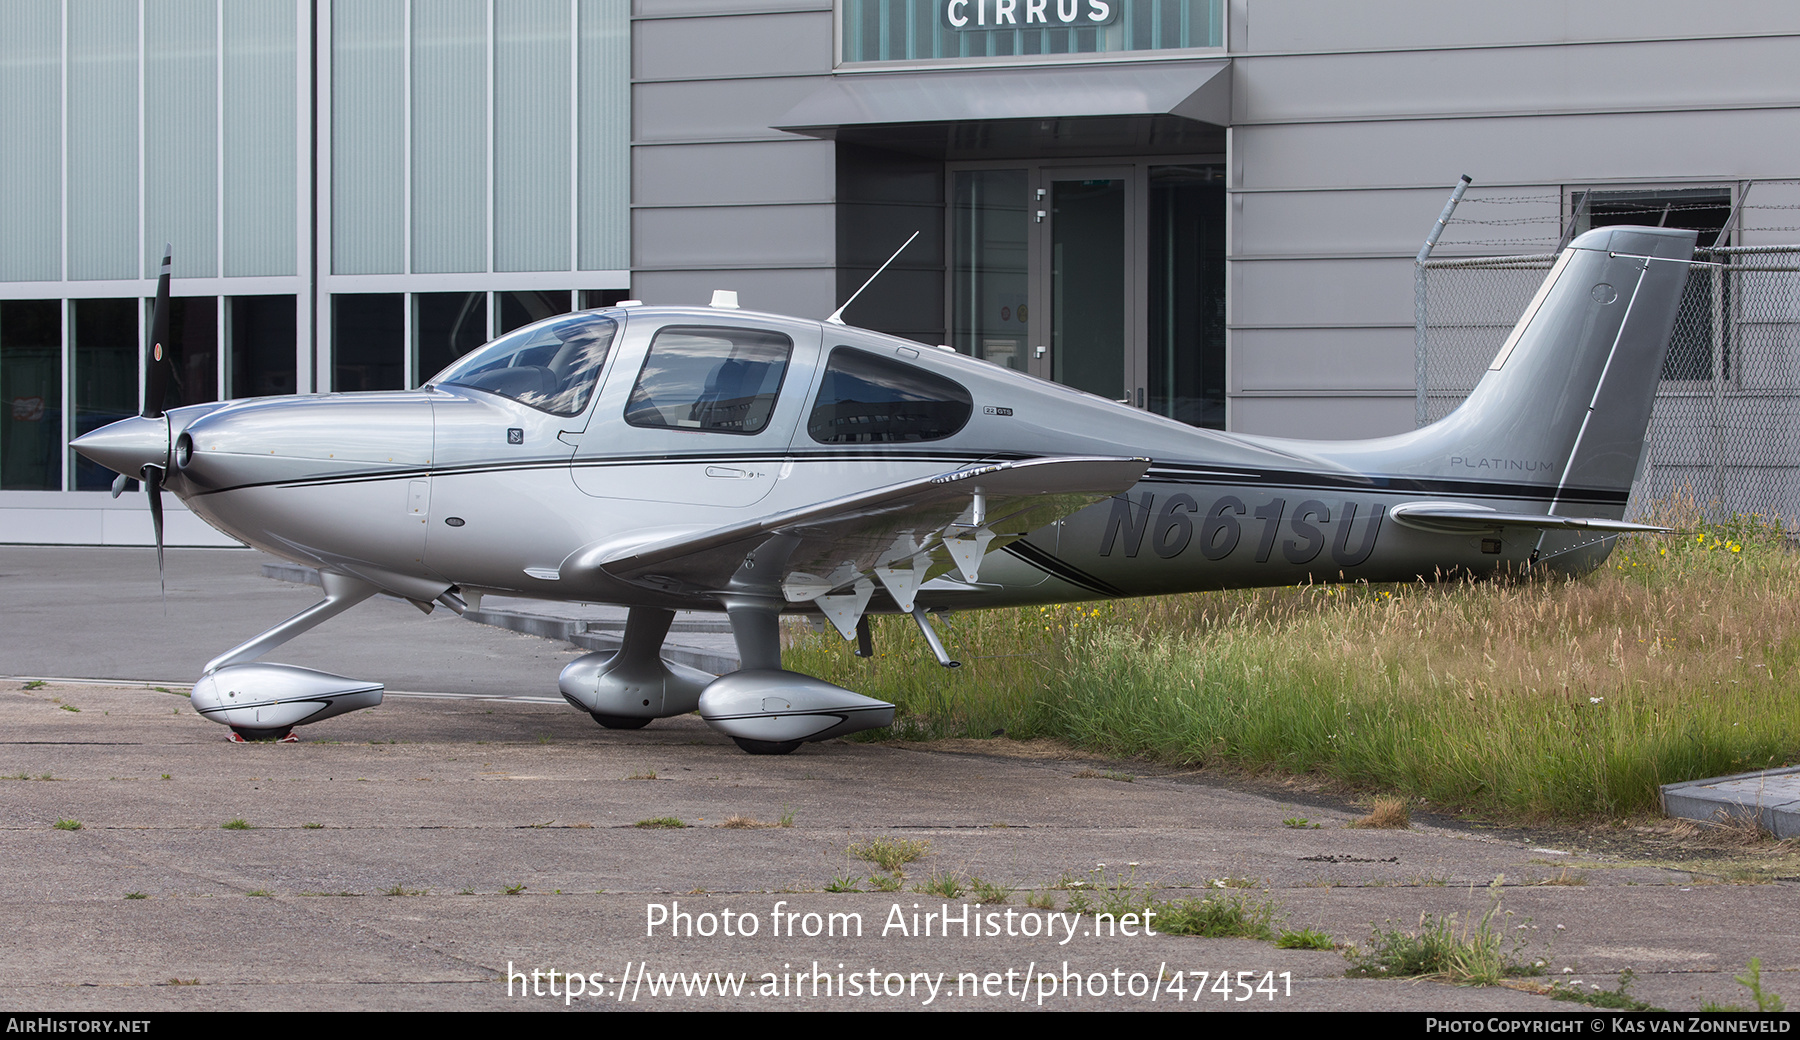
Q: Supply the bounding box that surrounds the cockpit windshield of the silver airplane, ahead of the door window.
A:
[430,313,619,416]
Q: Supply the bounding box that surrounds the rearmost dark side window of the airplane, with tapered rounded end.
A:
[806,347,974,444]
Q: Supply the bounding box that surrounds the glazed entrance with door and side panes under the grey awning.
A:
[949,160,1224,428]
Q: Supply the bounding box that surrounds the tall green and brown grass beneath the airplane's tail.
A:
[787,518,1800,817]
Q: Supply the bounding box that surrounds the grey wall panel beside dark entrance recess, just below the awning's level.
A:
[632,139,833,205]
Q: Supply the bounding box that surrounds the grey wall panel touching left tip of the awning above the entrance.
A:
[632,76,819,144]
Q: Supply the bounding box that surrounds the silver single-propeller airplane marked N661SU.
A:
[74,227,1696,754]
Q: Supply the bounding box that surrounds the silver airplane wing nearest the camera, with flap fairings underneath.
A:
[590,455,1150,635]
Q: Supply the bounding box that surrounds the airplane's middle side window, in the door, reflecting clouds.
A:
[625,327,794,434]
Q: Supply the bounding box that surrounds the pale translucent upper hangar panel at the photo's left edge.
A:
[0,4,63,281]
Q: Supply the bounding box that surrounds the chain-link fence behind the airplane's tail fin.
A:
[1415,247,1800,525]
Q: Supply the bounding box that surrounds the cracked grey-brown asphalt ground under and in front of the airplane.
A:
[0,547,1800,1020]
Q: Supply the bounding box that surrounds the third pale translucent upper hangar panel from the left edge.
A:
[144,0,220,277]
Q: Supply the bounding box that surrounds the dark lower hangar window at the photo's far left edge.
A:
[0,300,63,491]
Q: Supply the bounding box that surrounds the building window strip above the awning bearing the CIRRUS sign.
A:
[841,0,1226,63]
